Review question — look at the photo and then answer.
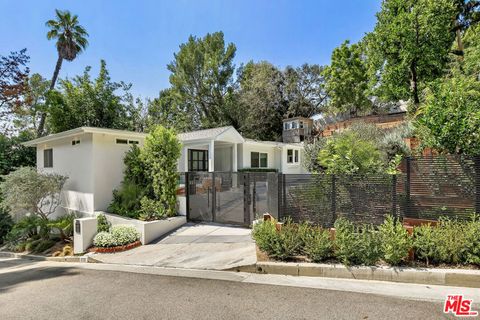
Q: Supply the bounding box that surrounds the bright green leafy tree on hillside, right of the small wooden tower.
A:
[324,41,372,116]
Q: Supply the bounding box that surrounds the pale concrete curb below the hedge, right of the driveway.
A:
[229,262,480,288]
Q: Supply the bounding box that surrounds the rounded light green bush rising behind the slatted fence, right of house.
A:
[318,131,384,174]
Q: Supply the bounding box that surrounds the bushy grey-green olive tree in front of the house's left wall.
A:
[0,167,68,219]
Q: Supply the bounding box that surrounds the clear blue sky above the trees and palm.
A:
[0,0,381,98]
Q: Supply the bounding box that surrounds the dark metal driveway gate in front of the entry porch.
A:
[185,172,278,226]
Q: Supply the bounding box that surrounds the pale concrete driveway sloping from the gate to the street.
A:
[92,223,257,270]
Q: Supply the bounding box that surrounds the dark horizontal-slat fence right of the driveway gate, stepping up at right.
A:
[278,156,480,226]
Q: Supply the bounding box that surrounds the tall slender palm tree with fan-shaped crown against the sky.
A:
[37,9,88,136]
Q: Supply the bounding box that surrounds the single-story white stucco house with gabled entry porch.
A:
[24,126,305,214]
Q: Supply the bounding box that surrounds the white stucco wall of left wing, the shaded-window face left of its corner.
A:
[37,134,94,214]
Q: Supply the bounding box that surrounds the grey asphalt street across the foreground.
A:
[0,262,448,320]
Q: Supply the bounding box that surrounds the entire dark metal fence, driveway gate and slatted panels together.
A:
[184,156,480,227]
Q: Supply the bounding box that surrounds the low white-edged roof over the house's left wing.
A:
[23,127,147,147]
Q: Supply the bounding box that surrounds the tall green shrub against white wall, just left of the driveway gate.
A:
[141,126,181,216]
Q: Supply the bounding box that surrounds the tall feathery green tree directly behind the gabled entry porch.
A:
[167,32,236,128]
